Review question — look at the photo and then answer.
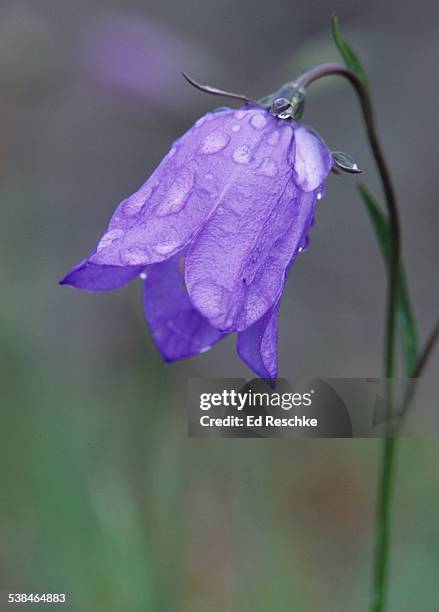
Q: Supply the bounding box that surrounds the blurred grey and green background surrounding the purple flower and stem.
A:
[0,0,439,612]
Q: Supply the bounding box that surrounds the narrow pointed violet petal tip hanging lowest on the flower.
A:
[237,300,279,381]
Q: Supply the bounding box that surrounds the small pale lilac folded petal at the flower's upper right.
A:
[294,125,333,191]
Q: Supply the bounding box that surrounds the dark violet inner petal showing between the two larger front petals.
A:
[143,253,224,361]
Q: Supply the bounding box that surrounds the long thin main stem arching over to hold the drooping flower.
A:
[294,64,401,612]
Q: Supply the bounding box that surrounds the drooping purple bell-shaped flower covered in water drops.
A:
[61,107,333,379]
